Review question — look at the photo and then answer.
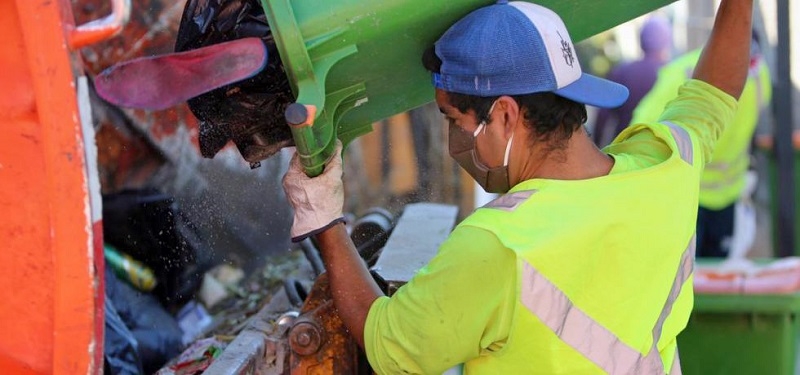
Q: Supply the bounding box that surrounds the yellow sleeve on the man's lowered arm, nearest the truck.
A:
[364,226,516,374]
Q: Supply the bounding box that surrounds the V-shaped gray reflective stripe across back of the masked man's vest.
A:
[520,237,695,375]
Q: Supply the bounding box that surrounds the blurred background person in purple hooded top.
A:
[592,15,672,147]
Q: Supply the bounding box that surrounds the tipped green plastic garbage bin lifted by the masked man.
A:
[261,0,674,175]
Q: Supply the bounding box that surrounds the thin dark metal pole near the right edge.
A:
[773,0,795,257]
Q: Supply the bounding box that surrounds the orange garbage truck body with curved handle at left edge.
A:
[0,0,129,374]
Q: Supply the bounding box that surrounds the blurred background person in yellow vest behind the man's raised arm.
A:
[632,33,772,257]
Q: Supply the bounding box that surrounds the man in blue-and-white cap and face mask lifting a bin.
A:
[284,0,753,374]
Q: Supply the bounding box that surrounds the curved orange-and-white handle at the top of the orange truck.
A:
[69,0,131,49]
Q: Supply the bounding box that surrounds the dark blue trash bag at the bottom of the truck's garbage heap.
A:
[105,267,183,374]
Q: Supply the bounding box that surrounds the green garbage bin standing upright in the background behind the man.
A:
[678,260,800,375]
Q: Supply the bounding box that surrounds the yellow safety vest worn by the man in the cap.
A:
[460,124,702,375]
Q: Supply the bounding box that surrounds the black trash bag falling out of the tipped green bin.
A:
[175,0,295,164]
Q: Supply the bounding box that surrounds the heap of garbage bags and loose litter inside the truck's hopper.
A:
[103,189,316,374]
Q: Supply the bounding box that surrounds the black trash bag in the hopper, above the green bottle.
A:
[103,189,210,311]
